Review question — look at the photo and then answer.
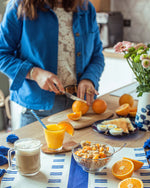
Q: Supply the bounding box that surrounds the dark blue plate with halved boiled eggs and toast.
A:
[92,118,138,137]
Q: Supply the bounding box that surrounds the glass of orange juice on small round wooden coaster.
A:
[44,124,66,151]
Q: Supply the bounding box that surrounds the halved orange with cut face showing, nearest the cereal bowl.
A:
[112,159,134,180]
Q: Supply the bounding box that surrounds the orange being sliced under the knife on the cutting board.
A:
[72,101,89,115]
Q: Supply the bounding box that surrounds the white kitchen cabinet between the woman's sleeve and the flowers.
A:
[98,50,135,95]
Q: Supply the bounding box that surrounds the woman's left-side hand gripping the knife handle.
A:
[27,67,64,94]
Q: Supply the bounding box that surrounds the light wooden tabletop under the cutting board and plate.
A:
[0,94,150,183]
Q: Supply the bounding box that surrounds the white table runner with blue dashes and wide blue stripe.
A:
[1,148,150,188]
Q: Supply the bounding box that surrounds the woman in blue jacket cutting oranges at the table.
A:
[0,0,104,126]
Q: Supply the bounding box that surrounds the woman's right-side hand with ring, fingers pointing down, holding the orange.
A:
[77,80,99,105]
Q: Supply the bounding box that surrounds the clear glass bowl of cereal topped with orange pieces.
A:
[72,141,115,173]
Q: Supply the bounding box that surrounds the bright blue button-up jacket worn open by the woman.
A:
[0,0,104,110]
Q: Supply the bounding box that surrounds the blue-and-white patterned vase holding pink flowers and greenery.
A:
[114,41,150,131]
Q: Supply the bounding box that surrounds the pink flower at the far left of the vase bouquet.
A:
[114,41,132,53]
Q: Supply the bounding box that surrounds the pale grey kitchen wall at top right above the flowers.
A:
[111,0,150,43]
